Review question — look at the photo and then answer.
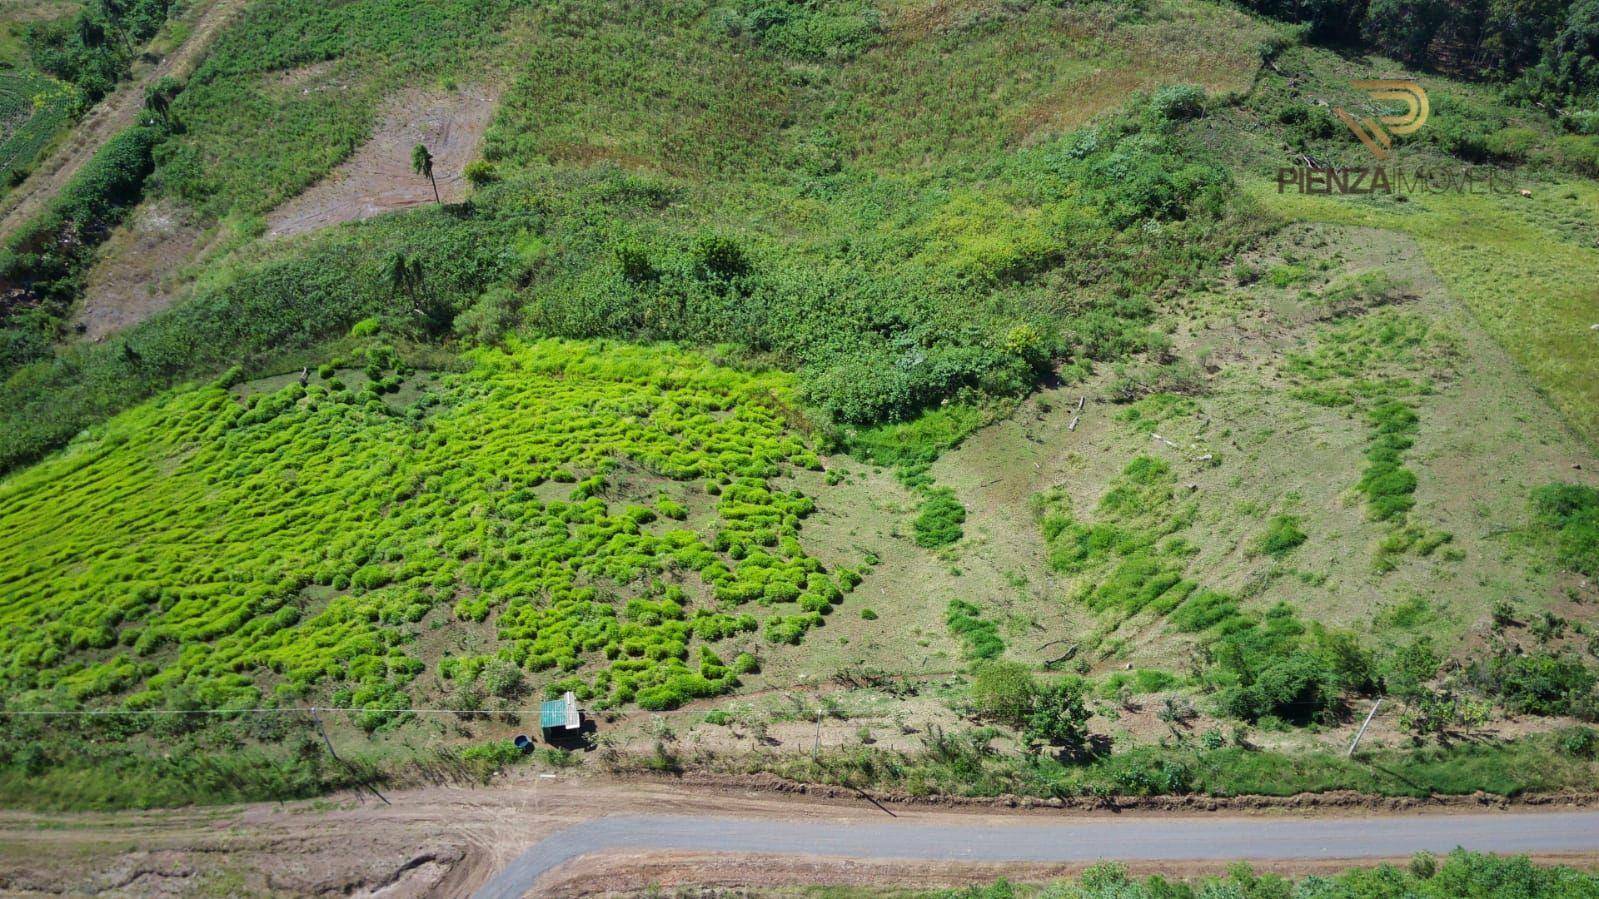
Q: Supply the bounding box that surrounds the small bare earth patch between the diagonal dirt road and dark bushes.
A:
[75,202,201,341]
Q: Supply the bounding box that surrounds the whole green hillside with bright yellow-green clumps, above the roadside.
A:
[0,0,1599,805]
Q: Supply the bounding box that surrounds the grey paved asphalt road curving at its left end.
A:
[477,811,1599,899]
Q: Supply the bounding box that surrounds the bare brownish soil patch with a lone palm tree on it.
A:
[267,88,499,237]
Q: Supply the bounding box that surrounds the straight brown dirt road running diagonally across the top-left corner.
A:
[0,0,248,242]
